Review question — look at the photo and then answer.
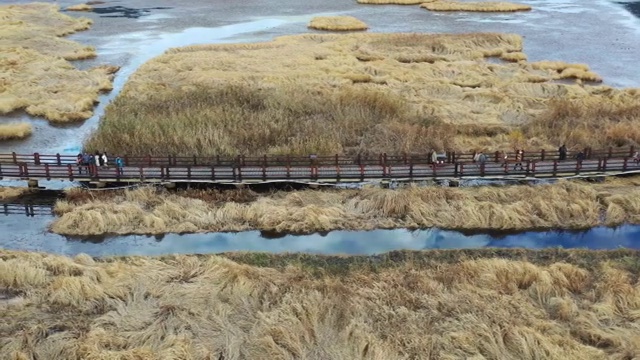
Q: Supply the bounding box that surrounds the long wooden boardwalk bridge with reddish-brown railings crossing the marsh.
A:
[0,147,640,184]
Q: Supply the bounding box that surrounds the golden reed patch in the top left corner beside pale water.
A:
[0,3,117,122]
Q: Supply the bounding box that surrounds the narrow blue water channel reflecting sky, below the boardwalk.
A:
[0,215,640,256]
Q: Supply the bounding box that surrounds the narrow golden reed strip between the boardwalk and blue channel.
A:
[51,182,640,235]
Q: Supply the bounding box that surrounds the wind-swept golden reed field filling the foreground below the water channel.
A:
[0,249,640,360]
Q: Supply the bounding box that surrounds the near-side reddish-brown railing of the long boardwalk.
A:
[0,156,640,182]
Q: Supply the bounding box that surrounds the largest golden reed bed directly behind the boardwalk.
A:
[85,33,640,156]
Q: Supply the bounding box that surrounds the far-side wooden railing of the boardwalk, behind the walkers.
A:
[0,146,636,167]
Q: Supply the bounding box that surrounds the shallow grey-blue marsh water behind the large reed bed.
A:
[0,0,640,153]
